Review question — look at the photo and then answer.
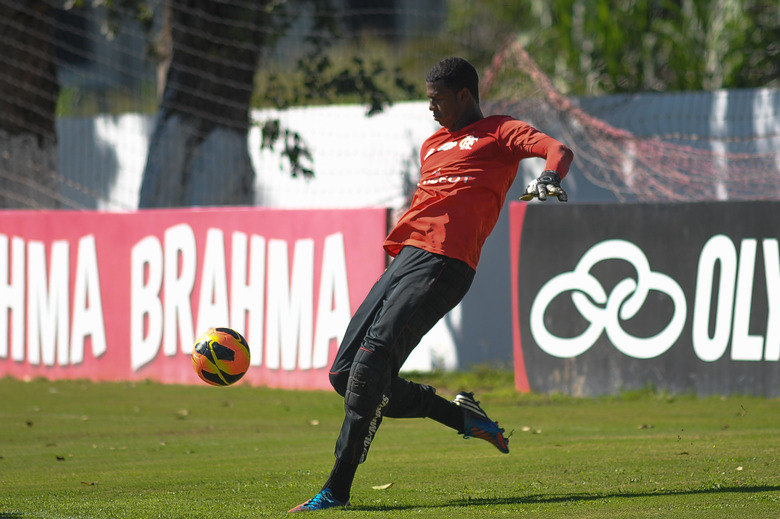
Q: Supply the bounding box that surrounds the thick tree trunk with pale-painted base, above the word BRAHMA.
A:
[139,0,269,207]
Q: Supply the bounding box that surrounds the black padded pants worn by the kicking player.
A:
[330,247,475,465]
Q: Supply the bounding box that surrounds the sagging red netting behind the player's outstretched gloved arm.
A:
[482,35,780,201]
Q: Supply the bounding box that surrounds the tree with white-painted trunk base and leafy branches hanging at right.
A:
[139,0,411,207]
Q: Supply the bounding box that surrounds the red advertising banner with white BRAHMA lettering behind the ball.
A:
[0,208,386,388]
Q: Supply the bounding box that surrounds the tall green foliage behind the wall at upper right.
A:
[450,0,780,95]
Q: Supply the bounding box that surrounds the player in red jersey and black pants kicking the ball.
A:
[290,58,574,512]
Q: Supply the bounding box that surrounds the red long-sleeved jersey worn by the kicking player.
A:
[384,115,568,269]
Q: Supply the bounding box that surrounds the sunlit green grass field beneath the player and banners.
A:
[0,374,780,519]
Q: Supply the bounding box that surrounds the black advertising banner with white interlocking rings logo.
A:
[510,202,780,397]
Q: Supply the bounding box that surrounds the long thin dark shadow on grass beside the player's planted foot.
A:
[348,485,780,519]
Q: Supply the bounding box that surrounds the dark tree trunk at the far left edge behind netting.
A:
[0,0,62,209]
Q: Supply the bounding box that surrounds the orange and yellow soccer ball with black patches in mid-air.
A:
[192,328,249,386]
